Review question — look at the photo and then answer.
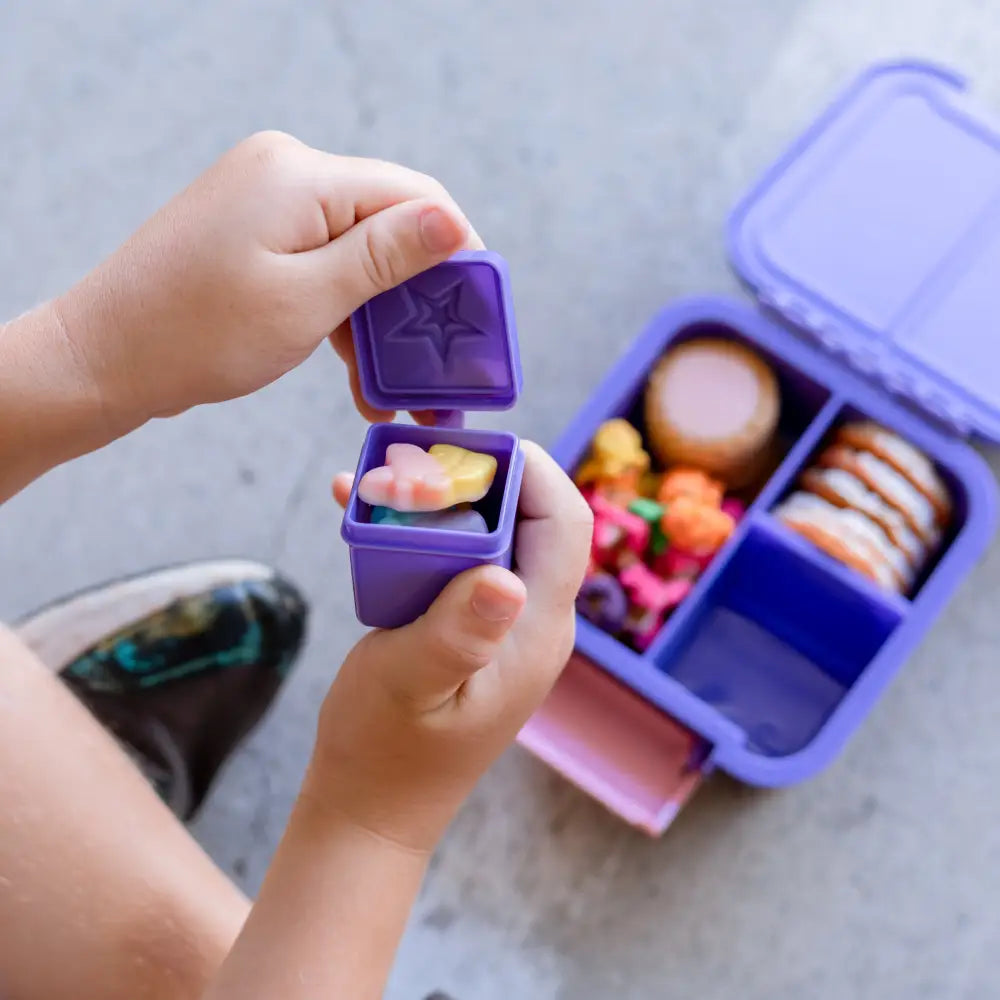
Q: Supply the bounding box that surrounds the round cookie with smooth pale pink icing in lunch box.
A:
[645,338,780,489]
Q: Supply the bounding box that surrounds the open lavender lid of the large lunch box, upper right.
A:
[728,62,1000,441]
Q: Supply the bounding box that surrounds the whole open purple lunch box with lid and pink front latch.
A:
[520,63,1000,835]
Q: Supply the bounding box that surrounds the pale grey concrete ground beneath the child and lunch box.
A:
[0,0,1000,1000]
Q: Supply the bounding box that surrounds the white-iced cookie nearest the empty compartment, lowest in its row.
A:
[774,493,912,592]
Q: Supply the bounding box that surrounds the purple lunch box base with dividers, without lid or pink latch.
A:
[543,298,997,786]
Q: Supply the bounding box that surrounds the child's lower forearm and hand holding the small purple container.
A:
[206,444,592,1000]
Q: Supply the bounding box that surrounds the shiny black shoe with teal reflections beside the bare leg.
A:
[17,560,307,820]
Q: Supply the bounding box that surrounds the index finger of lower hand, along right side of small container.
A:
[514,441,594,611]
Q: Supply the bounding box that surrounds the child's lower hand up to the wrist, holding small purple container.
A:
[312,443,592,851]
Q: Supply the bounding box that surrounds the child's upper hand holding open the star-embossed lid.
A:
[54,132,482,432]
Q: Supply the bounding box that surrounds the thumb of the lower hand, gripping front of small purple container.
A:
[368,566,527,711]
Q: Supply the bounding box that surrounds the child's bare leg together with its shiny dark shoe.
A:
[0,563,304,1000]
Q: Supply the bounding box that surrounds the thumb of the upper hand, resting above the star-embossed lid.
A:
[303,199,472,318]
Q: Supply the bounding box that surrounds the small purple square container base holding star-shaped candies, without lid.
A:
[341,424,524,628]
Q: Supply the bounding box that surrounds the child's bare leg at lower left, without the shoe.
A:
[0,629,248,1000]
